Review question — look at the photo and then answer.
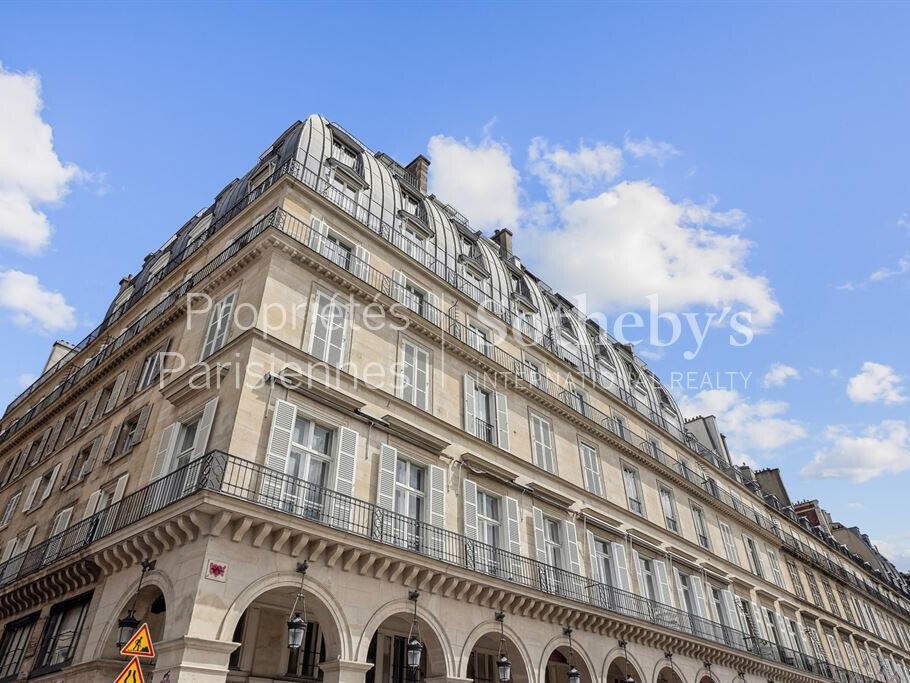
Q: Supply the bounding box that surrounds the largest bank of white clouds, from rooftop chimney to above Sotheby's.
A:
[429,130,781,332]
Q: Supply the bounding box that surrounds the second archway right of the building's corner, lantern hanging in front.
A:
[358,598,454,683]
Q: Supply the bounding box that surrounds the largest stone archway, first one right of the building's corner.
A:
[225,579,342,681]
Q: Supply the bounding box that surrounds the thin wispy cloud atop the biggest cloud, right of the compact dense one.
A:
[528,138,623,206]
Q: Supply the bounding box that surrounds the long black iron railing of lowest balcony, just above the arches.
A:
[0,451,892,683]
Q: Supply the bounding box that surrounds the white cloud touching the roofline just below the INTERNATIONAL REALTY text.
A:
[679,389,806,458]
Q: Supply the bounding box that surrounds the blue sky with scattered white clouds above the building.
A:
[0,3,910,569]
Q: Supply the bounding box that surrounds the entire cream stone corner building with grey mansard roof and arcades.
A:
[0,116,910,683]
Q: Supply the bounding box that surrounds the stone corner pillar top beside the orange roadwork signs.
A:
[152,636,240,683]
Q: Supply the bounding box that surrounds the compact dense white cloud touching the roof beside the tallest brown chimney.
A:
[428,135,521,229]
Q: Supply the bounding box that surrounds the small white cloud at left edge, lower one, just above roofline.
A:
[0,270,76,332]
